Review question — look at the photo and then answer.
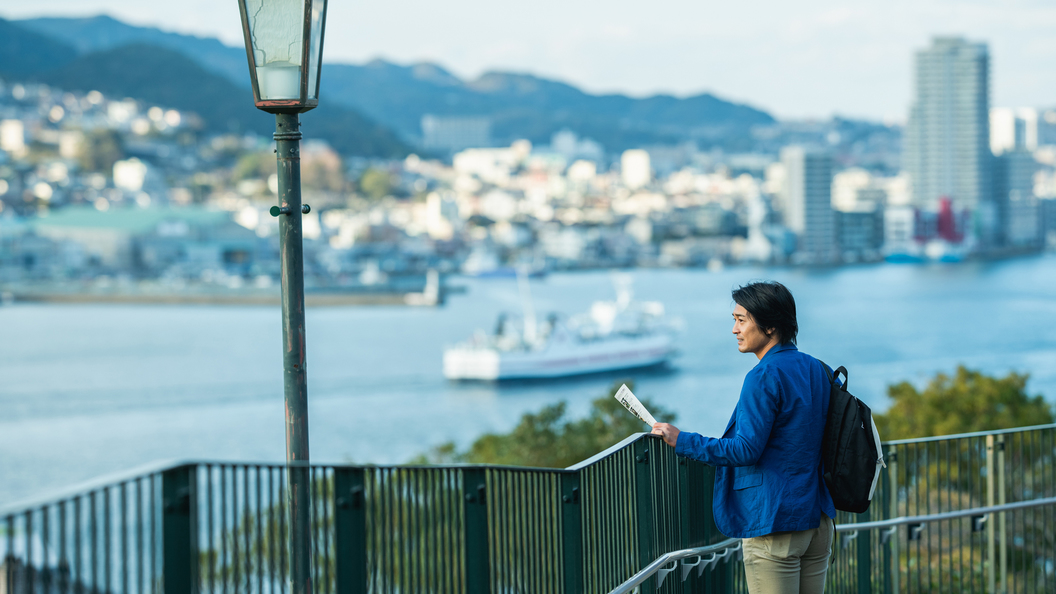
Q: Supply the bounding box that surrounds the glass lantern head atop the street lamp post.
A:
[239,0,326,113]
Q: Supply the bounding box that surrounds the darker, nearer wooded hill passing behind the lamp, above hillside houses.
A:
[30,44,408,156]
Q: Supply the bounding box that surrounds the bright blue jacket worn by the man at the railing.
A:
[675,344,836,538]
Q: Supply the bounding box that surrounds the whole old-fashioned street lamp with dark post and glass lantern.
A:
[239,0,326,594]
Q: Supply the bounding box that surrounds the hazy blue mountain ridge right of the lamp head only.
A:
[320,60,774,150]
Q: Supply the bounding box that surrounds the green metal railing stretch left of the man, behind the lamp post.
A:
[0,434,742,594]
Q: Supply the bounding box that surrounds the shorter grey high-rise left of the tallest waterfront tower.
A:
[781,146,838,264]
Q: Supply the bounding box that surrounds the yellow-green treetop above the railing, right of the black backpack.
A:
[873,366,1056,440]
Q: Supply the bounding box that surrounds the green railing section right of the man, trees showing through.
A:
[827,425,1056,594]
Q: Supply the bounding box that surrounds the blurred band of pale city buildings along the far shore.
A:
[0,39,1056,283]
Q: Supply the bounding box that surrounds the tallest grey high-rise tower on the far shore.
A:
[905,37,999,245]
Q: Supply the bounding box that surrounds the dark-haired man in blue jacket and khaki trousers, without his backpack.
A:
[653,281,836,594]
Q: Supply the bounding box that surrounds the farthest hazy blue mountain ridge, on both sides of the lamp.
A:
[17,16,774,151]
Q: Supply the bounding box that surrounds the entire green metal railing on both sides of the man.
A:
[0,425,1056,594]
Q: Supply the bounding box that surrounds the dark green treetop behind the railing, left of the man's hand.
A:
[412,380,676,468]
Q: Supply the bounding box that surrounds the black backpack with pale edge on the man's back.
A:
[822,363,886,514]
